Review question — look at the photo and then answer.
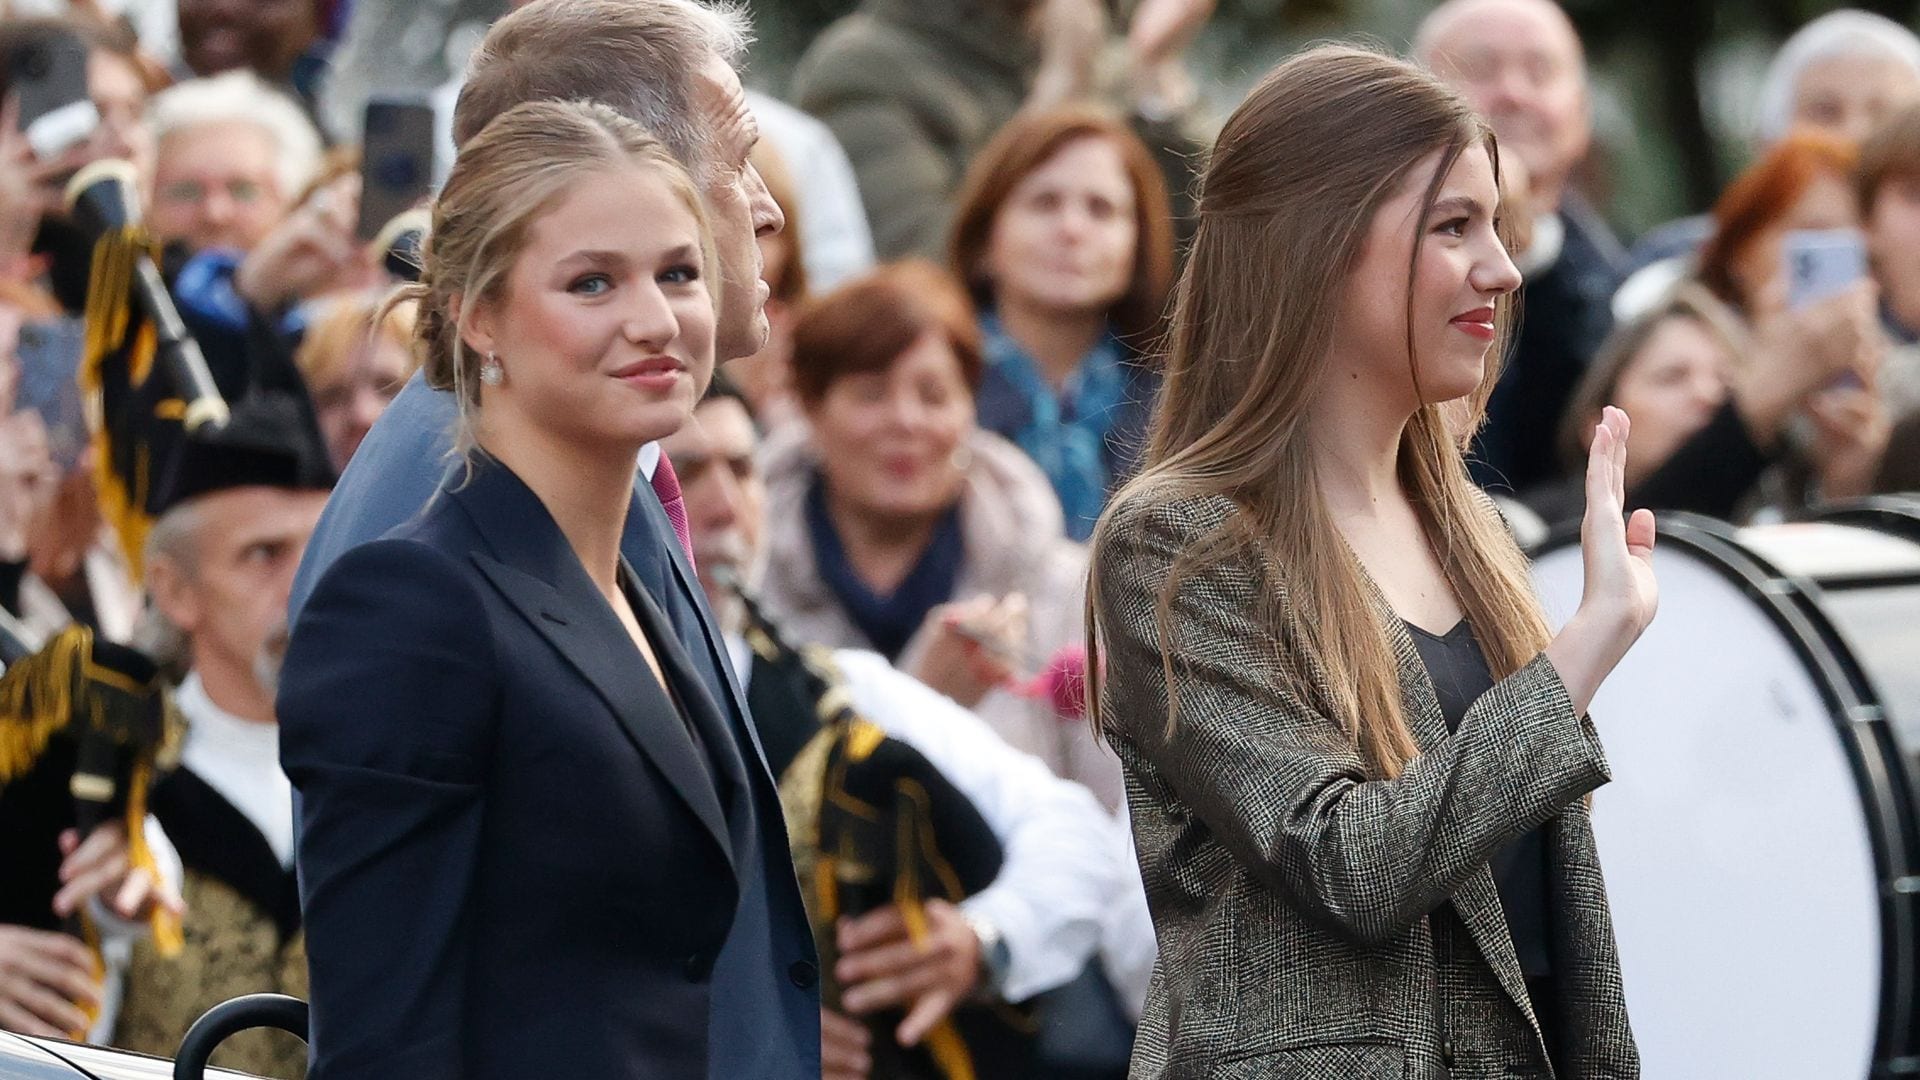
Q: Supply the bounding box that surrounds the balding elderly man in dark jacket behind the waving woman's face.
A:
[1413,0,1626,490]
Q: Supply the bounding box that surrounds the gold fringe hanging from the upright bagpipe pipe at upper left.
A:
[81,221,159,584]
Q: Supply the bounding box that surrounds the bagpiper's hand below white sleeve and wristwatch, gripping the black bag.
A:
[833,899,981,1045]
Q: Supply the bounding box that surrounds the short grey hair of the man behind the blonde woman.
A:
[453,0,753,179]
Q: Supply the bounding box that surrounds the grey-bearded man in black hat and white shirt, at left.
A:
[113,394,332,1076]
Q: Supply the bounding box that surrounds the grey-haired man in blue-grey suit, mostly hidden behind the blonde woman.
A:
[290,0,820,1080]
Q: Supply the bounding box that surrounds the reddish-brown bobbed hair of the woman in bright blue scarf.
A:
[948,104,1173,342]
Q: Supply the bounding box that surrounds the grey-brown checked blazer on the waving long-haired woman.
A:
[1096,498,1640,1080]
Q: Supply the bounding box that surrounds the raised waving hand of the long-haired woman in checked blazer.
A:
[1548,405,1659,713]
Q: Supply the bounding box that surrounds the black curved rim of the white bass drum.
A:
[1528,500,1920,1076]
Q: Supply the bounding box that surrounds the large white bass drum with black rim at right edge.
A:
[1534,513,1920,1080]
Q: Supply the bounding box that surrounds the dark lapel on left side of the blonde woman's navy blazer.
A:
[449,459,733,865]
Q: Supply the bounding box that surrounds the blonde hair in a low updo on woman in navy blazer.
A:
[388,102,720,455]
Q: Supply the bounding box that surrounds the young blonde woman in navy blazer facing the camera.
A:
[278,102,785,1080]
